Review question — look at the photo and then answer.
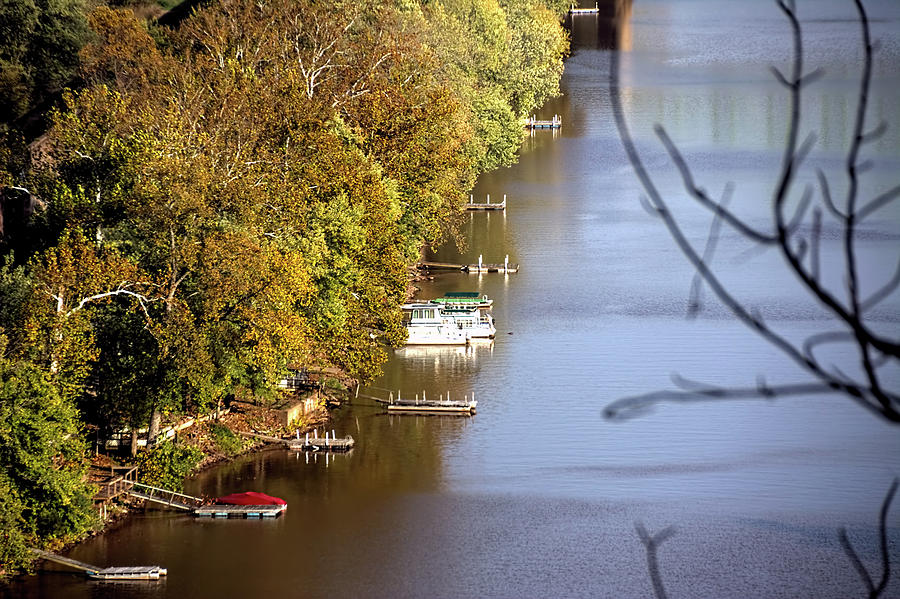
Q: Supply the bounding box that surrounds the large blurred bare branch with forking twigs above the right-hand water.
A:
[606,0,900,423]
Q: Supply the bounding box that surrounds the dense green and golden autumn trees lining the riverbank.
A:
[0,0,567,568]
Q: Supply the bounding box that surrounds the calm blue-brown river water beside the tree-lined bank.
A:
[6,0,900,599]
